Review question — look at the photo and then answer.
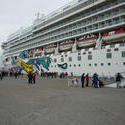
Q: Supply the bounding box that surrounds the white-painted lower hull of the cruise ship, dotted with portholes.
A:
[3,46,125,76]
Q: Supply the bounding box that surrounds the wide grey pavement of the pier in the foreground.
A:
[0,78,125,125]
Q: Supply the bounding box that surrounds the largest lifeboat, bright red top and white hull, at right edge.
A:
[102,28,125,42]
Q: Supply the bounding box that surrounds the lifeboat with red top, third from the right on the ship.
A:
[59,41,74,51]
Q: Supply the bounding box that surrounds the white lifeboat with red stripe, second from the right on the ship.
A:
[77,34,97,47]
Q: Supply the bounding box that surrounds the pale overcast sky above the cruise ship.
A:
[0,0,72,42]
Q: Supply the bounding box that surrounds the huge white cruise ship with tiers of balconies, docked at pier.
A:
[2,0,125,76]
